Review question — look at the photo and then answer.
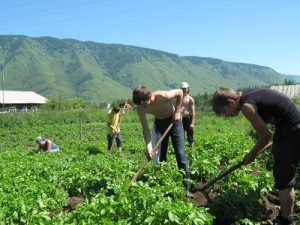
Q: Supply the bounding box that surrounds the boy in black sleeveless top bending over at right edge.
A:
[213,87,300,225]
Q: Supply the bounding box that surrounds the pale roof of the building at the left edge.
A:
[0,90,48,105]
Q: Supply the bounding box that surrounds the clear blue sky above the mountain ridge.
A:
[0,0,300,75]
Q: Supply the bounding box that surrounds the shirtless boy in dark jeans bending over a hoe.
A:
[132,85,190,188]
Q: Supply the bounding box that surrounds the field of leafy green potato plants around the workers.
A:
[0,110,300,225]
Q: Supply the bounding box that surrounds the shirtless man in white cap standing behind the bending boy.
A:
[181,82,195,148]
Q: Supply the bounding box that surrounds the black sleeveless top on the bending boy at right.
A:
[240,88,300,126]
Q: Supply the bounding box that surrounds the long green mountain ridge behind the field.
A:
[0,35,285,102]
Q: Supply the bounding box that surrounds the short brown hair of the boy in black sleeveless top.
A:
[212,87,238,115]
